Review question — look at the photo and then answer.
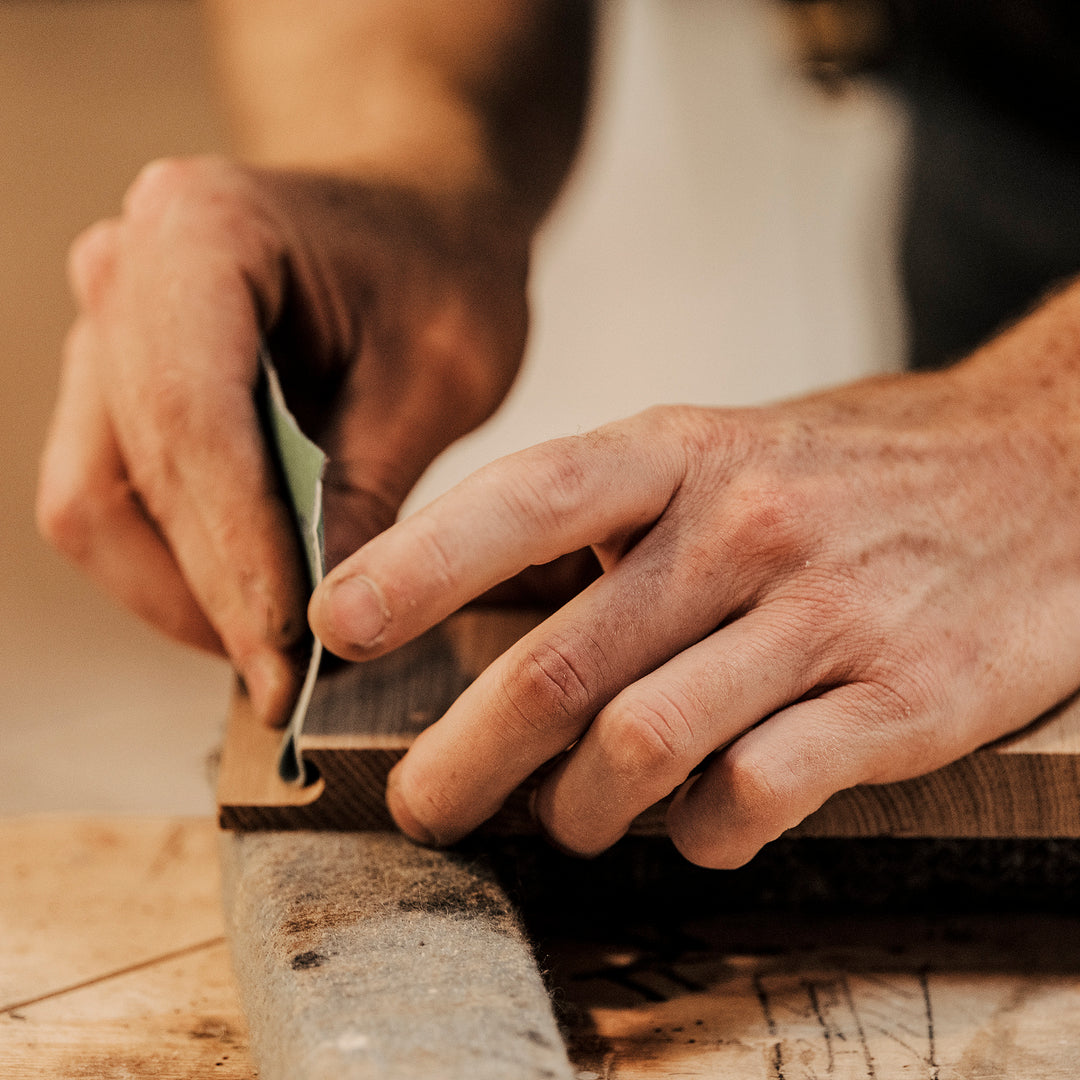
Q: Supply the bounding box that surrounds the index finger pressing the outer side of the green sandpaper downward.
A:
[89,238,306,719]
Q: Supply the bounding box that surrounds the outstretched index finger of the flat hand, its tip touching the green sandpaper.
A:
[309,414,684,660]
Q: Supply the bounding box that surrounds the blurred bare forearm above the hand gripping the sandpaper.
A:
[205,0,592,229]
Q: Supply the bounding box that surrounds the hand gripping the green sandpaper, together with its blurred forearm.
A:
[38,0,592,720]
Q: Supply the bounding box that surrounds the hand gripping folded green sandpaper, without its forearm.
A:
[39,159,527,719]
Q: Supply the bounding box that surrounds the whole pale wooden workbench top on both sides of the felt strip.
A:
[0,818,1080,1080]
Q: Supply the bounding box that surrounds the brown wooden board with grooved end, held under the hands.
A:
[218,610,1080,837]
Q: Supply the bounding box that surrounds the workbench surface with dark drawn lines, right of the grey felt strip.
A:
[549,916,1080,1080]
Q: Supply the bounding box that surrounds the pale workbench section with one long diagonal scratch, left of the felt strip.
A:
[0,816,255,1080]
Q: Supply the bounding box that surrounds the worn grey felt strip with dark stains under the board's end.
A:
[222,833,573,1080]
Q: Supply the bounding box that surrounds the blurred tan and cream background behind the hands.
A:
[0,0,907,813]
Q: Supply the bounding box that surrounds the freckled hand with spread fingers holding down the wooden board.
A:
[310,287,1080,867]
